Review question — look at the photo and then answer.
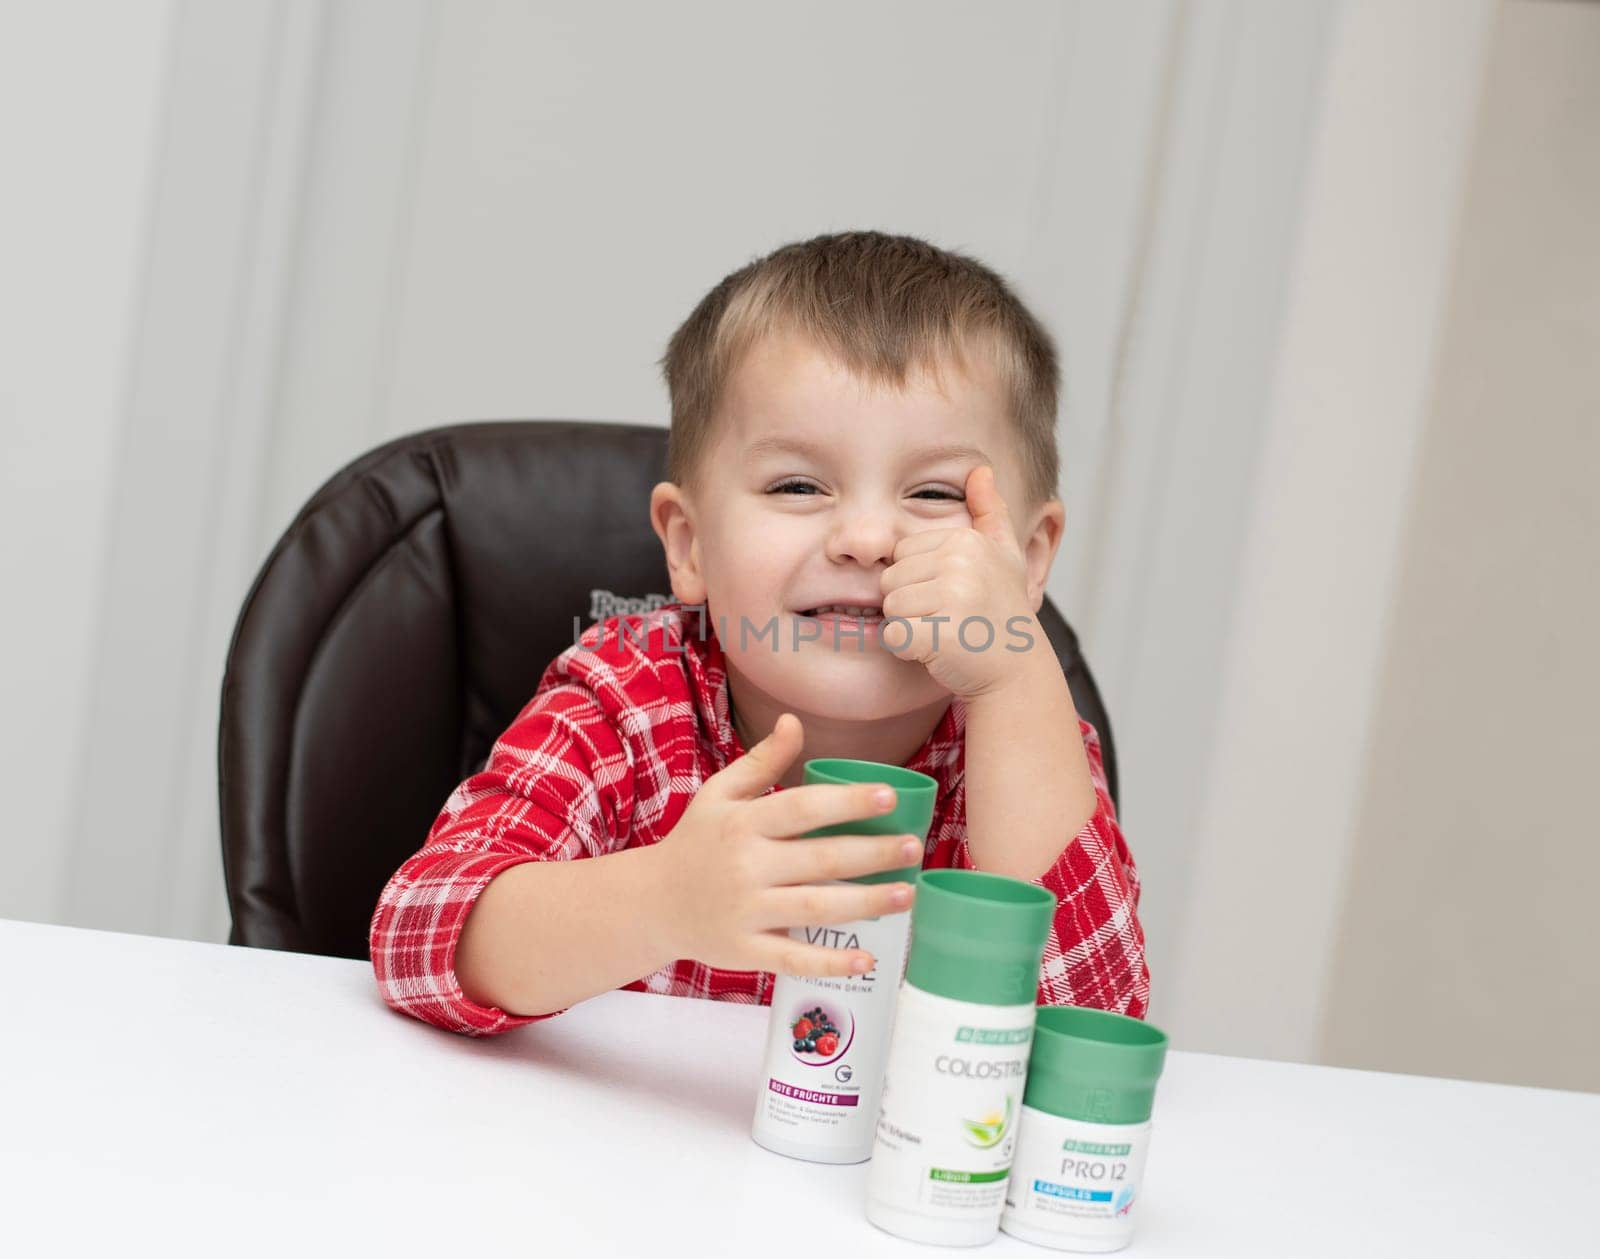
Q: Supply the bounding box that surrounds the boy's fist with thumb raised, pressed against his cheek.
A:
[882,464,1043,699]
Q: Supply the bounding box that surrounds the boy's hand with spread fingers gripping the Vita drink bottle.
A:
[659,713,923,976]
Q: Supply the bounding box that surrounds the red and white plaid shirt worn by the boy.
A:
[371,603,1150,1035]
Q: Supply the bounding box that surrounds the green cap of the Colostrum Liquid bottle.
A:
[906,870,1056,1006]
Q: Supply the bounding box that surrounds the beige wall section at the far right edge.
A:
[1322,3,1600,1089]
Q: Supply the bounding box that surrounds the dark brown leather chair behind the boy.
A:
[218,421,1117,958]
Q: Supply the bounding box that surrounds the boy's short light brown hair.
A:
[661,232,1059,507]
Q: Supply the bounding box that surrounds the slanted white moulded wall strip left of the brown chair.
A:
[61,0,323,939]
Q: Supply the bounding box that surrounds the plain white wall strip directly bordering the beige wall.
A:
[1170,0,1491,1061]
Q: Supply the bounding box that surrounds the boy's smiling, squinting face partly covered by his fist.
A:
[651,336,1061,721]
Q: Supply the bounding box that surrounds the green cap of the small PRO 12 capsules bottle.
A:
[1024,1011,1166,1123]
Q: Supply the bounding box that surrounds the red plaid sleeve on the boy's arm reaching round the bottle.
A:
[370,665,634,1035]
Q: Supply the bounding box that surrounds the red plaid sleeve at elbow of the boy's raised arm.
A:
[955,718,1150,1019]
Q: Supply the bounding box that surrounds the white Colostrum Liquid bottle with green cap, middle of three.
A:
[867,870,1056,1246]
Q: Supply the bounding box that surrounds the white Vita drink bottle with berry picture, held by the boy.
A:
[750,758,939,1163]
